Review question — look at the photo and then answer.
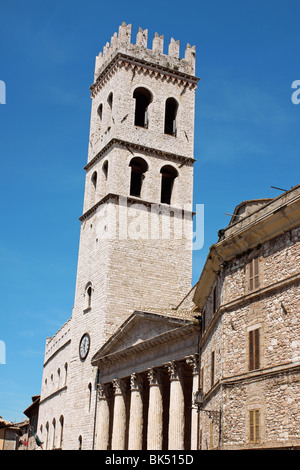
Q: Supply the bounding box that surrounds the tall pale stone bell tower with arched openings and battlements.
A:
[64,23,198,448]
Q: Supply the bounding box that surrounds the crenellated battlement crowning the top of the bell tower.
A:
[95,22,196,80]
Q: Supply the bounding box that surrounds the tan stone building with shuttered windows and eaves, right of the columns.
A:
[194,186,300,449]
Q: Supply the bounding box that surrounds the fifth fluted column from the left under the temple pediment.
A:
[167,361,184,450]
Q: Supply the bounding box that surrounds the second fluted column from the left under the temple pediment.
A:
[111,379,126,450]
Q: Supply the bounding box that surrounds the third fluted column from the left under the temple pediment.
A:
[128,374,143,450]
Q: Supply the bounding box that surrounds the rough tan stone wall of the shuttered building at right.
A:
[201,222,300,448]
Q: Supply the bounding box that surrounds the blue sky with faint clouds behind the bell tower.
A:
[0,0,300,420]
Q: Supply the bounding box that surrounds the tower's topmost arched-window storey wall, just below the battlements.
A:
[88,57,196,162]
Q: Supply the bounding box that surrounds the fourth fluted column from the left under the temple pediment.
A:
[147,368,163,450]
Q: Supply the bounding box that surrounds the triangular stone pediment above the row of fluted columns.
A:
[92,312,191,363]
